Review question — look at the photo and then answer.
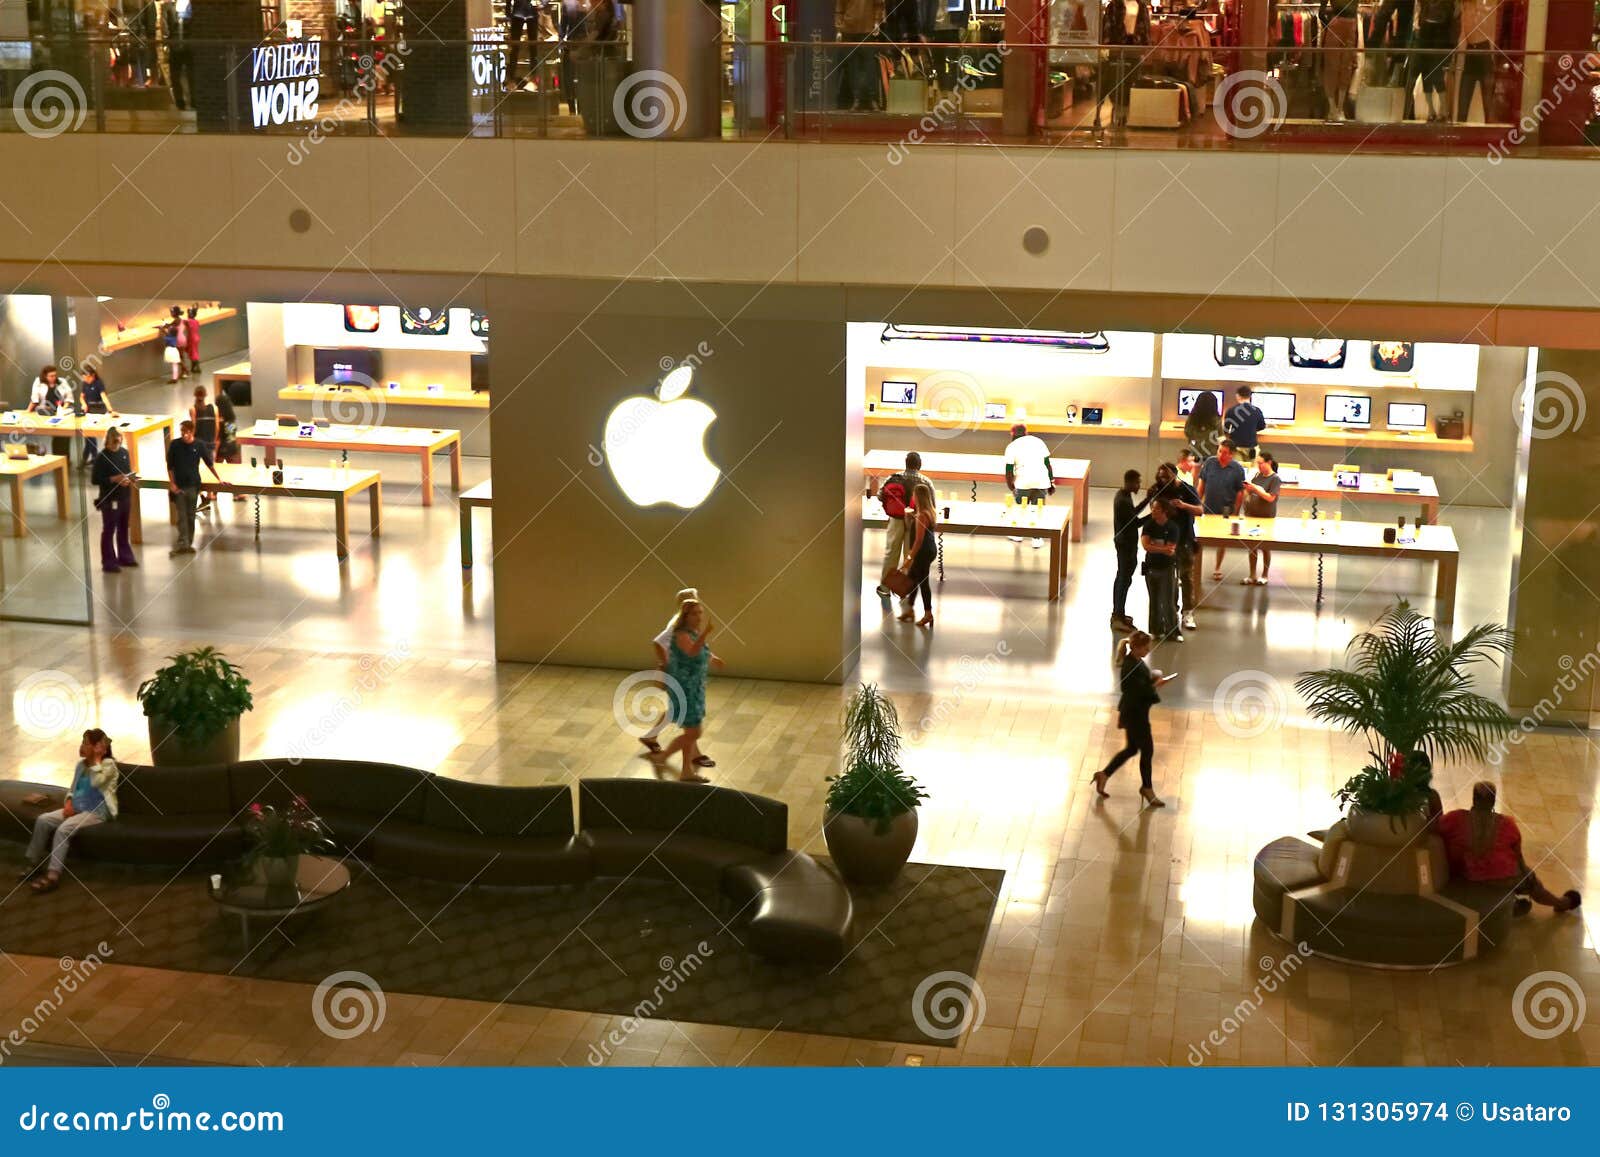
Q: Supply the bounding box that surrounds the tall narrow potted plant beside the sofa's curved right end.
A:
[822,683,928,883]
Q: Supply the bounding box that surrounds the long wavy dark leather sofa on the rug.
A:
[0,759,853,963]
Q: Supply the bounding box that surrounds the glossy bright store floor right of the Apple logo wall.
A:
[861,490,1512,706]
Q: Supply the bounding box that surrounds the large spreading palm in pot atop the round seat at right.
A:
[1294,600,1517,843]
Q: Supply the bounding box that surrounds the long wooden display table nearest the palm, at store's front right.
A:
[1195,514,1461,626]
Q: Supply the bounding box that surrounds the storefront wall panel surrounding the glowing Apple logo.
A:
[486,278,861,682]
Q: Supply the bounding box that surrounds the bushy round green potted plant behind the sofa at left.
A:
[138,647,254,767]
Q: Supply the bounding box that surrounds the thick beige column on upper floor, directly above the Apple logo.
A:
[626,0,722,141]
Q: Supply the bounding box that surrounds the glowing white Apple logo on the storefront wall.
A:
[605,365,722,510]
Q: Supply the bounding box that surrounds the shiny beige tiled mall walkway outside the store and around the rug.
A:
[0,624,1600,1066]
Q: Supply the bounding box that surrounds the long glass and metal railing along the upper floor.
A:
[0,30,1600,160]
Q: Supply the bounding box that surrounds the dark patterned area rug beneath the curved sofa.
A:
[0,842,1005,1047]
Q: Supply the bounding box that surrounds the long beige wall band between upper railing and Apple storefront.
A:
[9,133,1600,312]
